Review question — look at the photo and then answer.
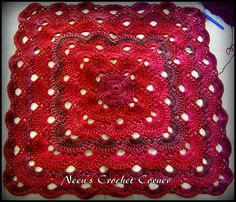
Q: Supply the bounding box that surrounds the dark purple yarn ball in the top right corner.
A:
[203,1,234,26]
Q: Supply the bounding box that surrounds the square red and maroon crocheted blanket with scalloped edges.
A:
[3,3,232,198]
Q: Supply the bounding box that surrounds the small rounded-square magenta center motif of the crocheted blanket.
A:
[99,74,134,105]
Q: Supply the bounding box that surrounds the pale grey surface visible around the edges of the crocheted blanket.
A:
[2,2,234,200]
